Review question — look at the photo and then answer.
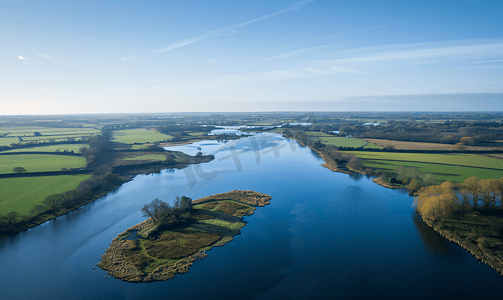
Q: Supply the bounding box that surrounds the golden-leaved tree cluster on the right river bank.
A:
[415,177,503,222]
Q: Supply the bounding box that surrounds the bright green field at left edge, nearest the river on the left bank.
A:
[0,175,91,215]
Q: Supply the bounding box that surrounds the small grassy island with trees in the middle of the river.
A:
[98,190,271,282]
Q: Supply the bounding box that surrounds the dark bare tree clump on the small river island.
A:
[141,196,192,225]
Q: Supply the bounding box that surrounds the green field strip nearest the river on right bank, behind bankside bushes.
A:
[362,159,503,182]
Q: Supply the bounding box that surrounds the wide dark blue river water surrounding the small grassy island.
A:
[0,134,503,299]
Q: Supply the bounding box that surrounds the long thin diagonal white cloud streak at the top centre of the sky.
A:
[155,0,316,53]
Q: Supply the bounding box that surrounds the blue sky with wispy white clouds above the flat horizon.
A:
[0,0,503,115]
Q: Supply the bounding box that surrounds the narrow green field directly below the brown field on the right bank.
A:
[342,151,503,170]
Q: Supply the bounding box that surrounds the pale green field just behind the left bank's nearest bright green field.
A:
[0,154,86,174]
